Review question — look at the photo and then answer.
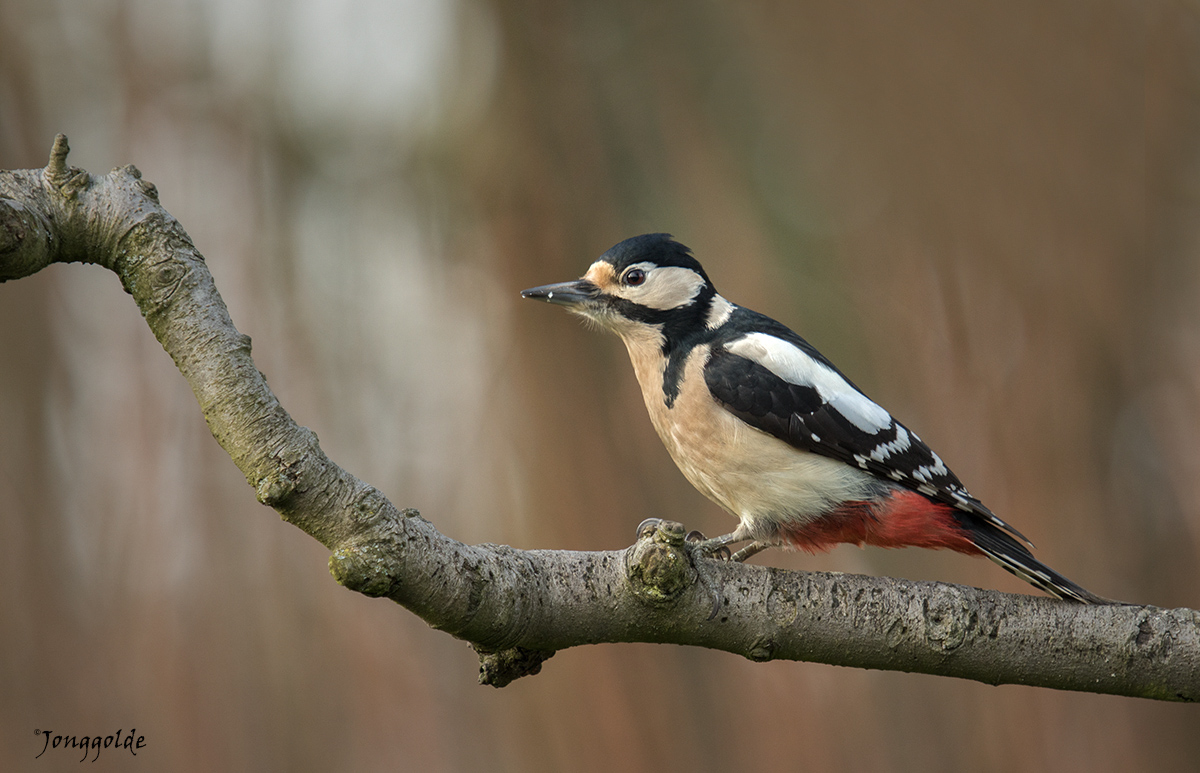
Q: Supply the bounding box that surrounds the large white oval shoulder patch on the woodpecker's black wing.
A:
[725,332,892,439]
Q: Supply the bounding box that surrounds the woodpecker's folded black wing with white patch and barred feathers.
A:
[704,310,1025,539]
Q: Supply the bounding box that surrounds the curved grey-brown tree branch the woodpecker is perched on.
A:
[0,136,1200,701]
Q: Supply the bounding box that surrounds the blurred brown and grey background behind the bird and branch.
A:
[0,0,1200,772]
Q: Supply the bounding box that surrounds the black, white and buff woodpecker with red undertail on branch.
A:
[521,234,1106,604]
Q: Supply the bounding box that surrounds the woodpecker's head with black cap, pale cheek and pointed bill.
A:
[521,228,728,341]
